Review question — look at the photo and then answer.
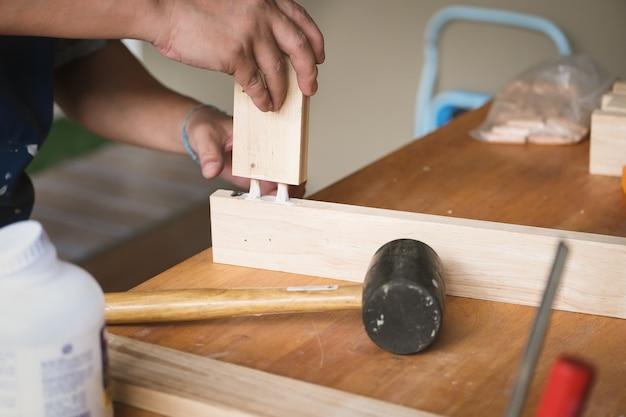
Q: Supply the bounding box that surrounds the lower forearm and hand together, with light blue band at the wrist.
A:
[54,42,304,196]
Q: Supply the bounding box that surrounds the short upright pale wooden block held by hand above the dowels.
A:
[233,65,309,185]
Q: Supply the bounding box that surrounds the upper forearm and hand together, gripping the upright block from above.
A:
[0,0,324,111]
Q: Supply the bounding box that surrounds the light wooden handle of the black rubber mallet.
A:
[105,285,362,324]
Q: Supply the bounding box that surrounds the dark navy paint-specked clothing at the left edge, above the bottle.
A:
[0,36,55,226]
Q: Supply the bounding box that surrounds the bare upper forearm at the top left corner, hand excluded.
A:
[0,0,158,42]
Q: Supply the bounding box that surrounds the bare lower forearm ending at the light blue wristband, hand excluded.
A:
[55,42,197,153]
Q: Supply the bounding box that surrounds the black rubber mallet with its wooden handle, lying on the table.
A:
[105,239,445,354]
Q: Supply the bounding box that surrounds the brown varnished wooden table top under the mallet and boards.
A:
[109,109,626,417]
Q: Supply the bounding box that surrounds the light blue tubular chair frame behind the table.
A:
[413,6,572,137]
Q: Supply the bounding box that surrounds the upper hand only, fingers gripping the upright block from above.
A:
[151,0,324,111]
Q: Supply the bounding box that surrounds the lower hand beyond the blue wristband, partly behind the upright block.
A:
[187,106,306,198]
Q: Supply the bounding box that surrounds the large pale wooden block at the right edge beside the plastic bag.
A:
[589,110,626,177]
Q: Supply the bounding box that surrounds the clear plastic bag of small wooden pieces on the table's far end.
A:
[471,55,613,145]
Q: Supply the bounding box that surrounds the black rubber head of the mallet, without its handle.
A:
[363,239,445,354]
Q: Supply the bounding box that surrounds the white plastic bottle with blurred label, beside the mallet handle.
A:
[0,221,112,417]
